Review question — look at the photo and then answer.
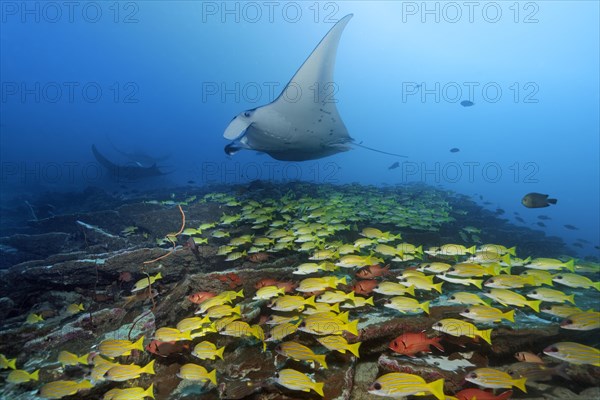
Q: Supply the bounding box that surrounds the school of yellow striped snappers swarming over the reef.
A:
[0,190,600,400]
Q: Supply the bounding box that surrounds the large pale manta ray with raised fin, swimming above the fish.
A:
[223,14,403,161]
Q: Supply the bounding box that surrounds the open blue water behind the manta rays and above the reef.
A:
[0,1,600,256]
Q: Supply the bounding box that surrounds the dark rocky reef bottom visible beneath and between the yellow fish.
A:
[0,182,600,400]
